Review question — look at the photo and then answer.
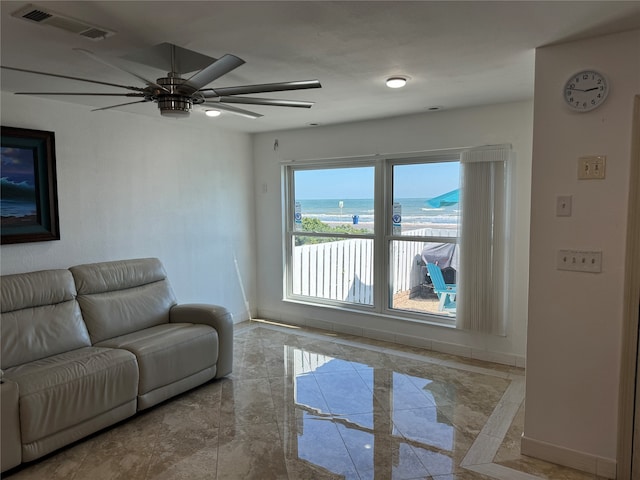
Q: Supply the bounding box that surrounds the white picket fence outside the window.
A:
[292,228,457,305]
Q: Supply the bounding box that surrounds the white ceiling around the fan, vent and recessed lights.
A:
[0,0,640,132]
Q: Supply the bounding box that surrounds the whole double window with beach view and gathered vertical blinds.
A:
[283,146,510,334]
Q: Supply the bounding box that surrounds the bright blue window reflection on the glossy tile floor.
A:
[284,346,468,479]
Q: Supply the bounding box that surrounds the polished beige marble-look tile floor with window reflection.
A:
[3,322,598,480]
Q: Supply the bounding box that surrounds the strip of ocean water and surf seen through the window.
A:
[298,198,460,225]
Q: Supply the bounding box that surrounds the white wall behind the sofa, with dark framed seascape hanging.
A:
[0,93,255,321]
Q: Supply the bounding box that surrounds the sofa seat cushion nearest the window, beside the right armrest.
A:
[96,323,218,395]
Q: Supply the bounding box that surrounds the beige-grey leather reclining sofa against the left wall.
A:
[0,258,233,472]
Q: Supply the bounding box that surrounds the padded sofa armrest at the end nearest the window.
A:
[169,303,233,378]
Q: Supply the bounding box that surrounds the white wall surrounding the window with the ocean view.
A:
[254,101,533,364]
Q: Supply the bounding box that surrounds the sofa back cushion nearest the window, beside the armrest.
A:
[70,258,176,344]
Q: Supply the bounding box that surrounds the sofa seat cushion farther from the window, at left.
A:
[5,347,138,444]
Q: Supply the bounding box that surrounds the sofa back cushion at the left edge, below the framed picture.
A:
[0,270,91,369]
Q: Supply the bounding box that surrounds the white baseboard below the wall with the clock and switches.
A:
[520,435,616,479]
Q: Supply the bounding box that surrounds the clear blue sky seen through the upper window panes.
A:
[295,162,460,200]
